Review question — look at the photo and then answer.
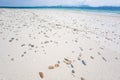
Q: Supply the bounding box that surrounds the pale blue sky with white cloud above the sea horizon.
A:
[0,0,120,6]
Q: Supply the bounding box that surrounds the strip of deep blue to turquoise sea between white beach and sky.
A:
[1,6,120,14]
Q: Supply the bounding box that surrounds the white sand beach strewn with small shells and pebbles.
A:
[0,9,120,80]
